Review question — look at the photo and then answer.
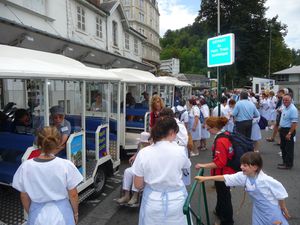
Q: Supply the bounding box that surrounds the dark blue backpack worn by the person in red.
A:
[214,131,254,171]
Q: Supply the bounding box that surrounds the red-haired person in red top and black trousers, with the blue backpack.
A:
[195,116,253,225]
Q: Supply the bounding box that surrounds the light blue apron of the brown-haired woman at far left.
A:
[27,199,75,225]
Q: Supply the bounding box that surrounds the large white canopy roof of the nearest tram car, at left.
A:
[0,45,120,81]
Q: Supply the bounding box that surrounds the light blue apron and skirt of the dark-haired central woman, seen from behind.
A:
[139,185,187,225]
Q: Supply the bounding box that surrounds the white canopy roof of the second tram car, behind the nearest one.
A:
[109,68,174,85]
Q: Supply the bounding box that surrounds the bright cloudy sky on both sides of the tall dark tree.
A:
[158,0,300,49]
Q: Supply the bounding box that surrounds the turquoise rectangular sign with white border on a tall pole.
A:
[207,33,235,67]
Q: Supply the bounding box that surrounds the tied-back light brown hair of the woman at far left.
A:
[37,127,61,155]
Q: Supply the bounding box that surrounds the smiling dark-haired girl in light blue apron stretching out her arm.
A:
[195,152,290,225]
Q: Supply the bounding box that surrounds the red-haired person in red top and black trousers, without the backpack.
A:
[195,116,236,225]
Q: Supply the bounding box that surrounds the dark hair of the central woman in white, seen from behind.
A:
[151,116,179,143]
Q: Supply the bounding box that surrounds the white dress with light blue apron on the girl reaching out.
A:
[224,171,288,225]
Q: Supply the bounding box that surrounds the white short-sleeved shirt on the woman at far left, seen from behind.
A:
[12,157,83,203]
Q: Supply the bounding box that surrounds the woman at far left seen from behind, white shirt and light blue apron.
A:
[12,127,83,225]
